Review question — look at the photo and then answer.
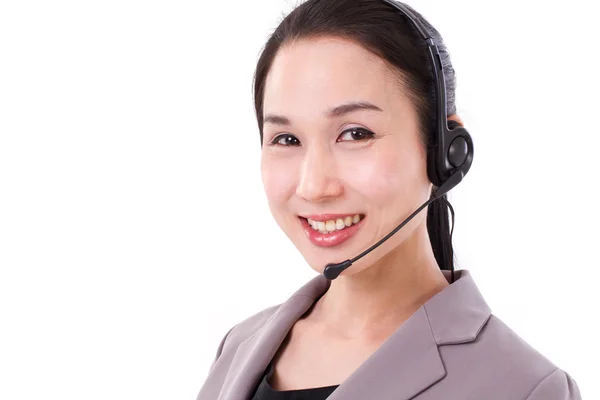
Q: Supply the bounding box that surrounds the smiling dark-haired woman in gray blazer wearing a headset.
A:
[198,0,581,400]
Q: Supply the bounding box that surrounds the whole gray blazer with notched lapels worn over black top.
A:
[197,269,581,400]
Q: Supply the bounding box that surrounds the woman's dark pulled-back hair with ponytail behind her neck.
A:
[254,0,456,271]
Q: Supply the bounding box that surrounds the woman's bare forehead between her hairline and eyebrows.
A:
[263,37,402,118]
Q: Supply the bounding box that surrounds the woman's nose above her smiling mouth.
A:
[296,148,343,203]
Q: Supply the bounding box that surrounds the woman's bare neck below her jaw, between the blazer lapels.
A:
[310,221,449,340]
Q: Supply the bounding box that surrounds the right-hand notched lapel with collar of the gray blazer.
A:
[328,270,491,400]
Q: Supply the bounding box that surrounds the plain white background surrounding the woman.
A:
[0,0,600,400]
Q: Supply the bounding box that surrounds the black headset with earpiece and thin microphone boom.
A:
[323,0,473,282]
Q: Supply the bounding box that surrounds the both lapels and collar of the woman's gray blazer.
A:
[219,269,491,400]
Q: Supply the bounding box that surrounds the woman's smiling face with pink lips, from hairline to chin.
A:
[261,38,431,276]
